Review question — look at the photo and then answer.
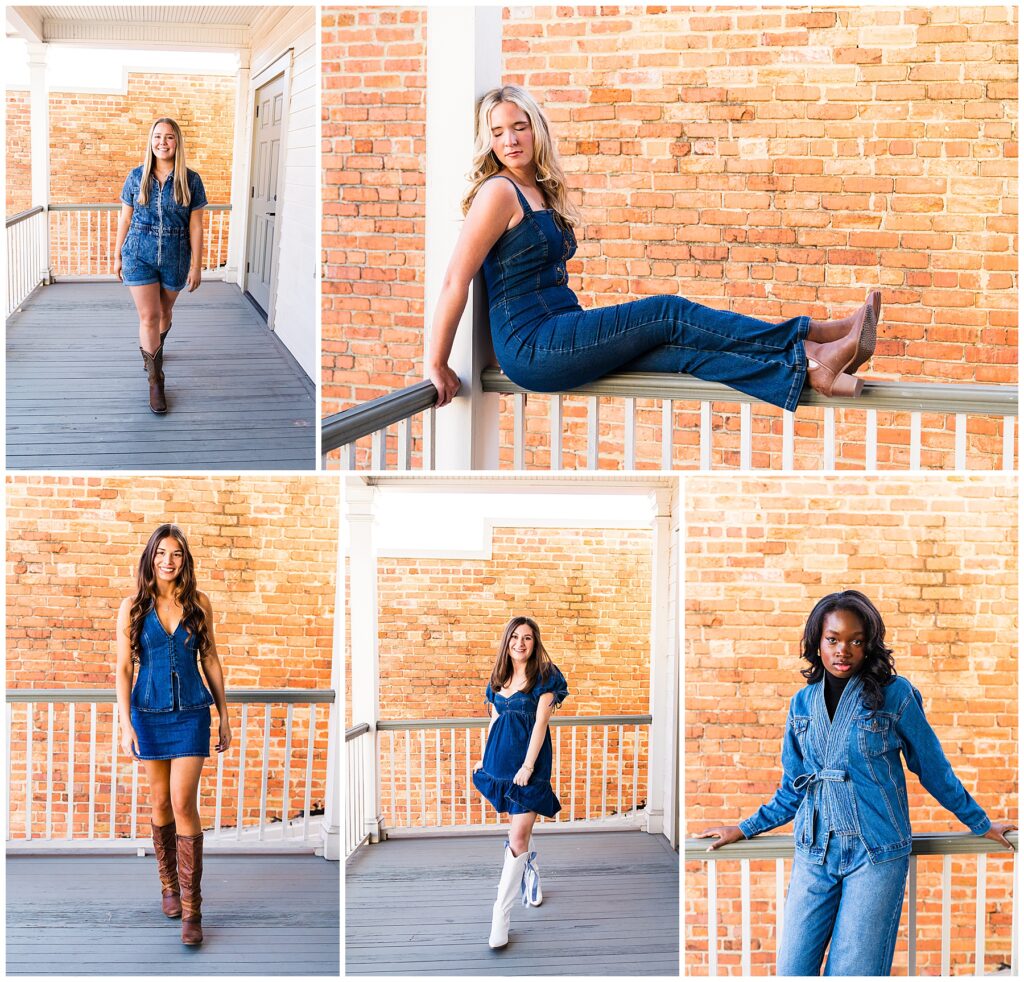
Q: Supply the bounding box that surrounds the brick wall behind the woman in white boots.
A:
[378,527,651,824]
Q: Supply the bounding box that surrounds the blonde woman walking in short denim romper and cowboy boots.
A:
[114,117,207,413]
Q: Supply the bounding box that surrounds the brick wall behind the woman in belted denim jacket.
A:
[684,476,1018,975]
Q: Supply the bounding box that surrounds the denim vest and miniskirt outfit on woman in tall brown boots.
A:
[131,607,213,761]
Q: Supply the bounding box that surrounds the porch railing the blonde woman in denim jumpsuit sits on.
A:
[322,369,1017,471]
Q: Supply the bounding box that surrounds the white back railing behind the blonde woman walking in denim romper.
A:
[49,204,231,281]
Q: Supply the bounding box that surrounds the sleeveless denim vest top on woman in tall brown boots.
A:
[131,608,213,713]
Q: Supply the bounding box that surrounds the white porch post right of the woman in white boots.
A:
[646,487,679,840]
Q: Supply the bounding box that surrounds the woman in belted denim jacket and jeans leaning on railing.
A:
[699,590,1017,976]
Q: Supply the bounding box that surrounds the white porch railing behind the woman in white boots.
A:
[358,715,651,848]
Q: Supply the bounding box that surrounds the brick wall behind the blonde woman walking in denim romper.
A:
[7,72,238,274]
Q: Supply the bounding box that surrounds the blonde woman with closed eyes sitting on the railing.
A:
[426,85,882,410]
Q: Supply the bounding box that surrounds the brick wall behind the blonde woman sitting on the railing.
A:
[324,6,1017,468]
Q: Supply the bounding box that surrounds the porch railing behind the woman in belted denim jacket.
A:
[685,832,1018,977]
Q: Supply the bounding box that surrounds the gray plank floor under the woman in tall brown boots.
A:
[6,855,340,976]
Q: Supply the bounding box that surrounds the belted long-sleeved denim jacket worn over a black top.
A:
[739,677,991,863]
